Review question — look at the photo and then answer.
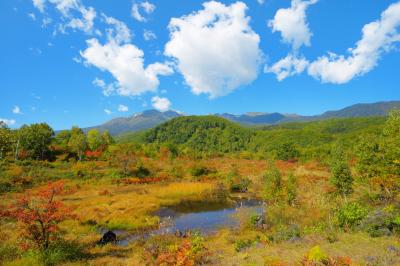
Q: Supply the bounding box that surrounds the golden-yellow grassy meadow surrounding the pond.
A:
[0,157,400,265]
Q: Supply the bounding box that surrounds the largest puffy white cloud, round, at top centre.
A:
[165,1,263,98]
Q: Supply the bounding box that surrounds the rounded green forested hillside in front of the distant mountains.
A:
[135,116,386,158]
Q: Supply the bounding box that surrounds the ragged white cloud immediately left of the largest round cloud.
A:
[81,15,173,96]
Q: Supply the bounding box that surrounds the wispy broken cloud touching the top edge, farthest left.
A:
[32,0,96,33]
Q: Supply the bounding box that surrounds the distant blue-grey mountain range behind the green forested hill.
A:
[84,101,400,136]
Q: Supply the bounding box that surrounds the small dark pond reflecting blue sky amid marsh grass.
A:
[108,199,265,246]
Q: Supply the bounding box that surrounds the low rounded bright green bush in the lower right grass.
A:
[337,202,368,229]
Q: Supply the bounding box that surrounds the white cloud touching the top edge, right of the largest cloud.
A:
[268,0,318,50]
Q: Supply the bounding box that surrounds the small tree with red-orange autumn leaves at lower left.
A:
[1,181,71,250]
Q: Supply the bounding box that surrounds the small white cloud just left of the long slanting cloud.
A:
[264,54,309,81]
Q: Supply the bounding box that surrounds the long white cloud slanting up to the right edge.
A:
[308,2,400,84]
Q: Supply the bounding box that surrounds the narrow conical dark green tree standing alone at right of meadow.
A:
[330,146,354,197]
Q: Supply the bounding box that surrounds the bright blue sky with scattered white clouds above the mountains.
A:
[0,0,400,129]
